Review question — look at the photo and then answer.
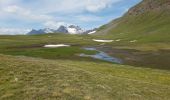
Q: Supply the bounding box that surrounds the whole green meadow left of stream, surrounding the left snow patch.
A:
[0,34,101,60]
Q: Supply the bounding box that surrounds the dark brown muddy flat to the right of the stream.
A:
[95,46,170,70]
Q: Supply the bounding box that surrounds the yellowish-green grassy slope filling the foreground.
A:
[0,55,170,100]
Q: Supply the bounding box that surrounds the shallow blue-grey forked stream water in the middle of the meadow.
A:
[80,48,123,64]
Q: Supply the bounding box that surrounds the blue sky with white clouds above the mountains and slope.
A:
[0,0,141,35]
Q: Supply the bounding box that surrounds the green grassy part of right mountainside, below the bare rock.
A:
[102,12,170,43]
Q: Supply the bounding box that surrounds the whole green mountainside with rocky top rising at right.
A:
[95,0,170,42]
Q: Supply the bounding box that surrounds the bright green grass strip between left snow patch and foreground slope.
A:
[0,47,97,60]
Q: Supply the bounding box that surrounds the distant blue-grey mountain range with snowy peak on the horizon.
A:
[27,25,85,35]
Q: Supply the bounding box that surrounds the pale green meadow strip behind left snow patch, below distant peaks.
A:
[0,34,94,47]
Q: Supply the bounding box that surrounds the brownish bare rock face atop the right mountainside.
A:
[126,0,170,16]
